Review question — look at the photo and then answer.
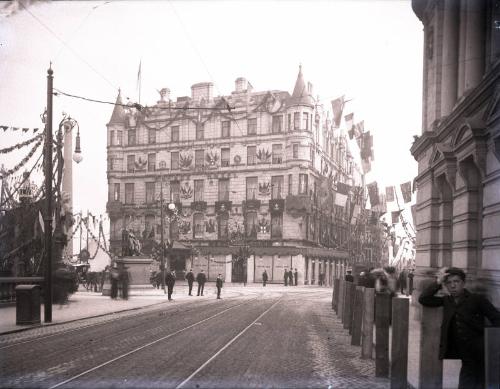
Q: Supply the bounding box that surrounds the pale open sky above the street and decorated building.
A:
[0,0,423,258]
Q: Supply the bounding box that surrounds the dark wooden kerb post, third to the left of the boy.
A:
[375,293,391,377]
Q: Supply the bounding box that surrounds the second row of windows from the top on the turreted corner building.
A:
[115,143,314,173]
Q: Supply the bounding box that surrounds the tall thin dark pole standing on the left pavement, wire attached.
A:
[44,63,54,323]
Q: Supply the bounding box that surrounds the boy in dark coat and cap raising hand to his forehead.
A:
[418,267,500,389]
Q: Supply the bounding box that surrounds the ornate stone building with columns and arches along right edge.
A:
[409,0,500,388]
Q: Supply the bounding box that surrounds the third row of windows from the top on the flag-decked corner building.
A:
[110,174,308,204]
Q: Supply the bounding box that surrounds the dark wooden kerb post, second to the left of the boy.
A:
[391,297,410,389]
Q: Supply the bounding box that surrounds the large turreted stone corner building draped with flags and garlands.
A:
[107,66,363,283]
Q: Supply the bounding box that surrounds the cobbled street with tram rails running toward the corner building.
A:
[0,286,389,388]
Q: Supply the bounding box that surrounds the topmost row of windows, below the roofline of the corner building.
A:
[109,112,312,146]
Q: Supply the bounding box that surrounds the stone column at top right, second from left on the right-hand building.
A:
[465,0,486,91]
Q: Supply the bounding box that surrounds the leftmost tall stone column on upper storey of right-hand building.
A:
[441,0,460,116]
